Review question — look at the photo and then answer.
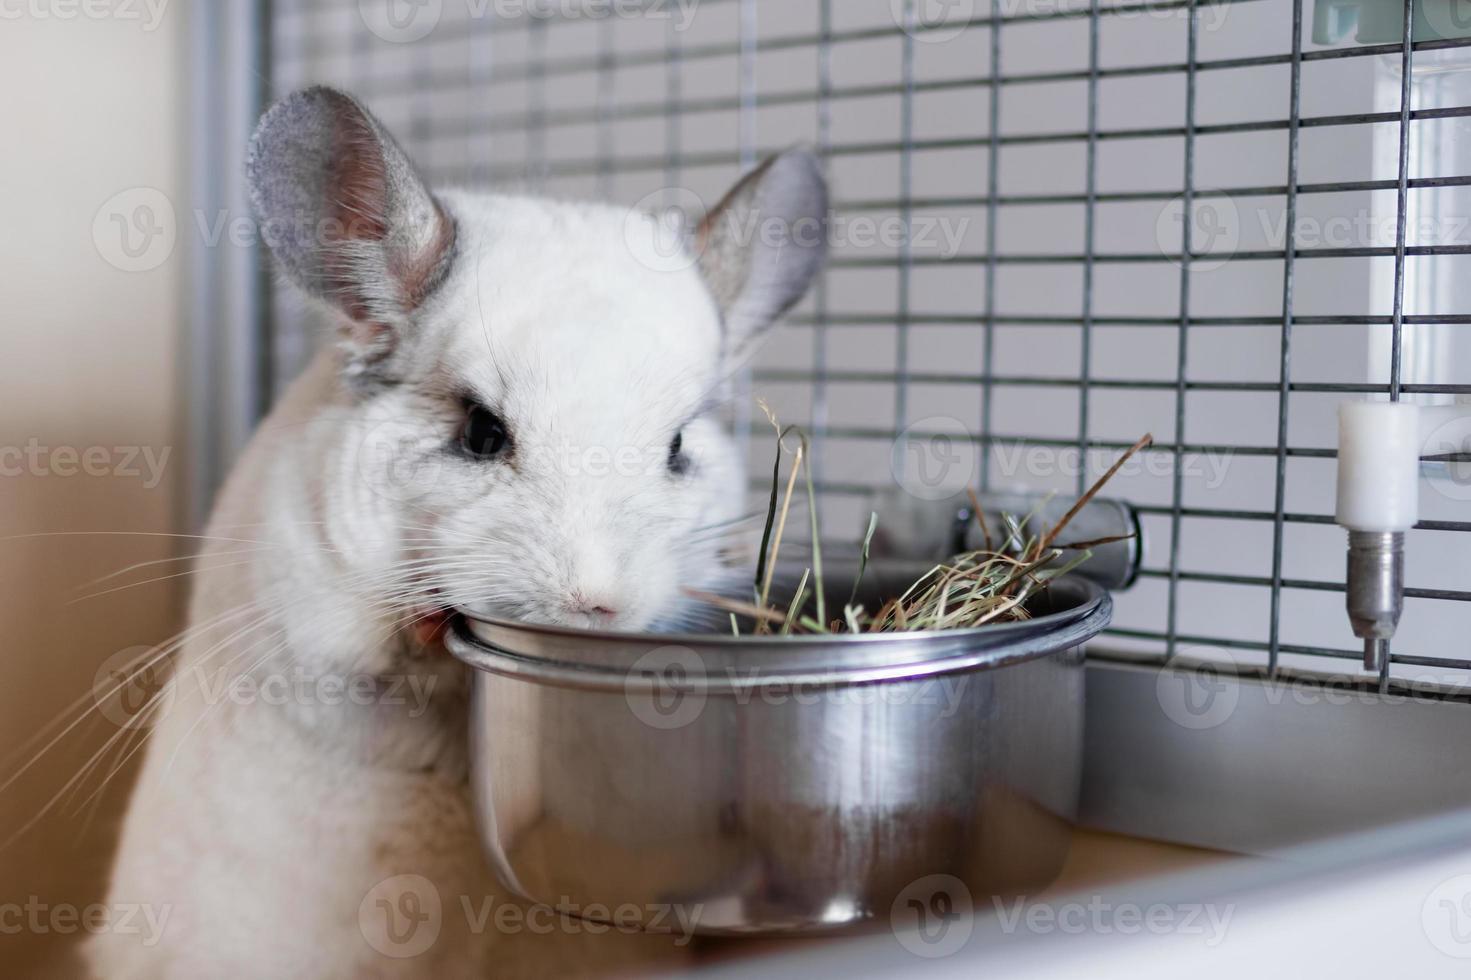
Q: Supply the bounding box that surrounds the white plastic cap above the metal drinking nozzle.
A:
[1339,402,1420,531]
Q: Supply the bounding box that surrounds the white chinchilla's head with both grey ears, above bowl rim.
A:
[247,88,827,630]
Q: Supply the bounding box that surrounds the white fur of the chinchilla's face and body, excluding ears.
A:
[88,194,743,979]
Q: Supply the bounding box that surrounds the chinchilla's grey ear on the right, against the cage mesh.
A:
[696,149,828,364]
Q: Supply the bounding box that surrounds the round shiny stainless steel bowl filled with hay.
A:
[449,578,1112,934]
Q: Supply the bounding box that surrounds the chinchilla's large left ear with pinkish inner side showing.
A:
[246,85,455,372]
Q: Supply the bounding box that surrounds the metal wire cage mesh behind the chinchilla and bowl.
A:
[272,0,1471,678]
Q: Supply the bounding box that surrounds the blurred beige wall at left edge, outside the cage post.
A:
[0,0,187,976]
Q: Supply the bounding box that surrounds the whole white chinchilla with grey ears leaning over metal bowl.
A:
[87,88,827,980]
